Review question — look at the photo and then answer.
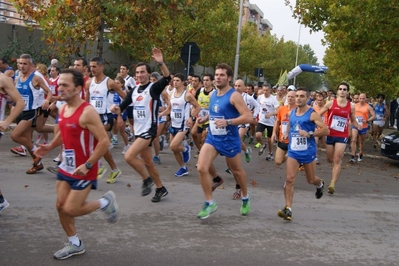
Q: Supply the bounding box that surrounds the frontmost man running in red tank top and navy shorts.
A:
[35,69,118,260]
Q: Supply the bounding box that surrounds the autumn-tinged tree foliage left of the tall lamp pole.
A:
[15,0,238,68]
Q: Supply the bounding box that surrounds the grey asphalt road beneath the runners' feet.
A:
[0,131,399,266]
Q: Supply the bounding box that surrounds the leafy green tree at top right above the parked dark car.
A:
[286,0,399,98]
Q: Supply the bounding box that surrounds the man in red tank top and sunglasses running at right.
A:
[319,82,361,194]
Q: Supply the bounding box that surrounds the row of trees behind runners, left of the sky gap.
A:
[11,0,322,89]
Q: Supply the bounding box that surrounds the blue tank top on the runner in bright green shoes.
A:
[208,88,240,141]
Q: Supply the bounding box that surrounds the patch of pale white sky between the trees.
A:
[250,0,326,65]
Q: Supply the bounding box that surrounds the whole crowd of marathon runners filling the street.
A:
[0,48,390,259]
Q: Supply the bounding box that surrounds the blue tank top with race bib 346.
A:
[288,108,317,162]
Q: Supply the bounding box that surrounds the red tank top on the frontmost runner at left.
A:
[58,102,98,180]
